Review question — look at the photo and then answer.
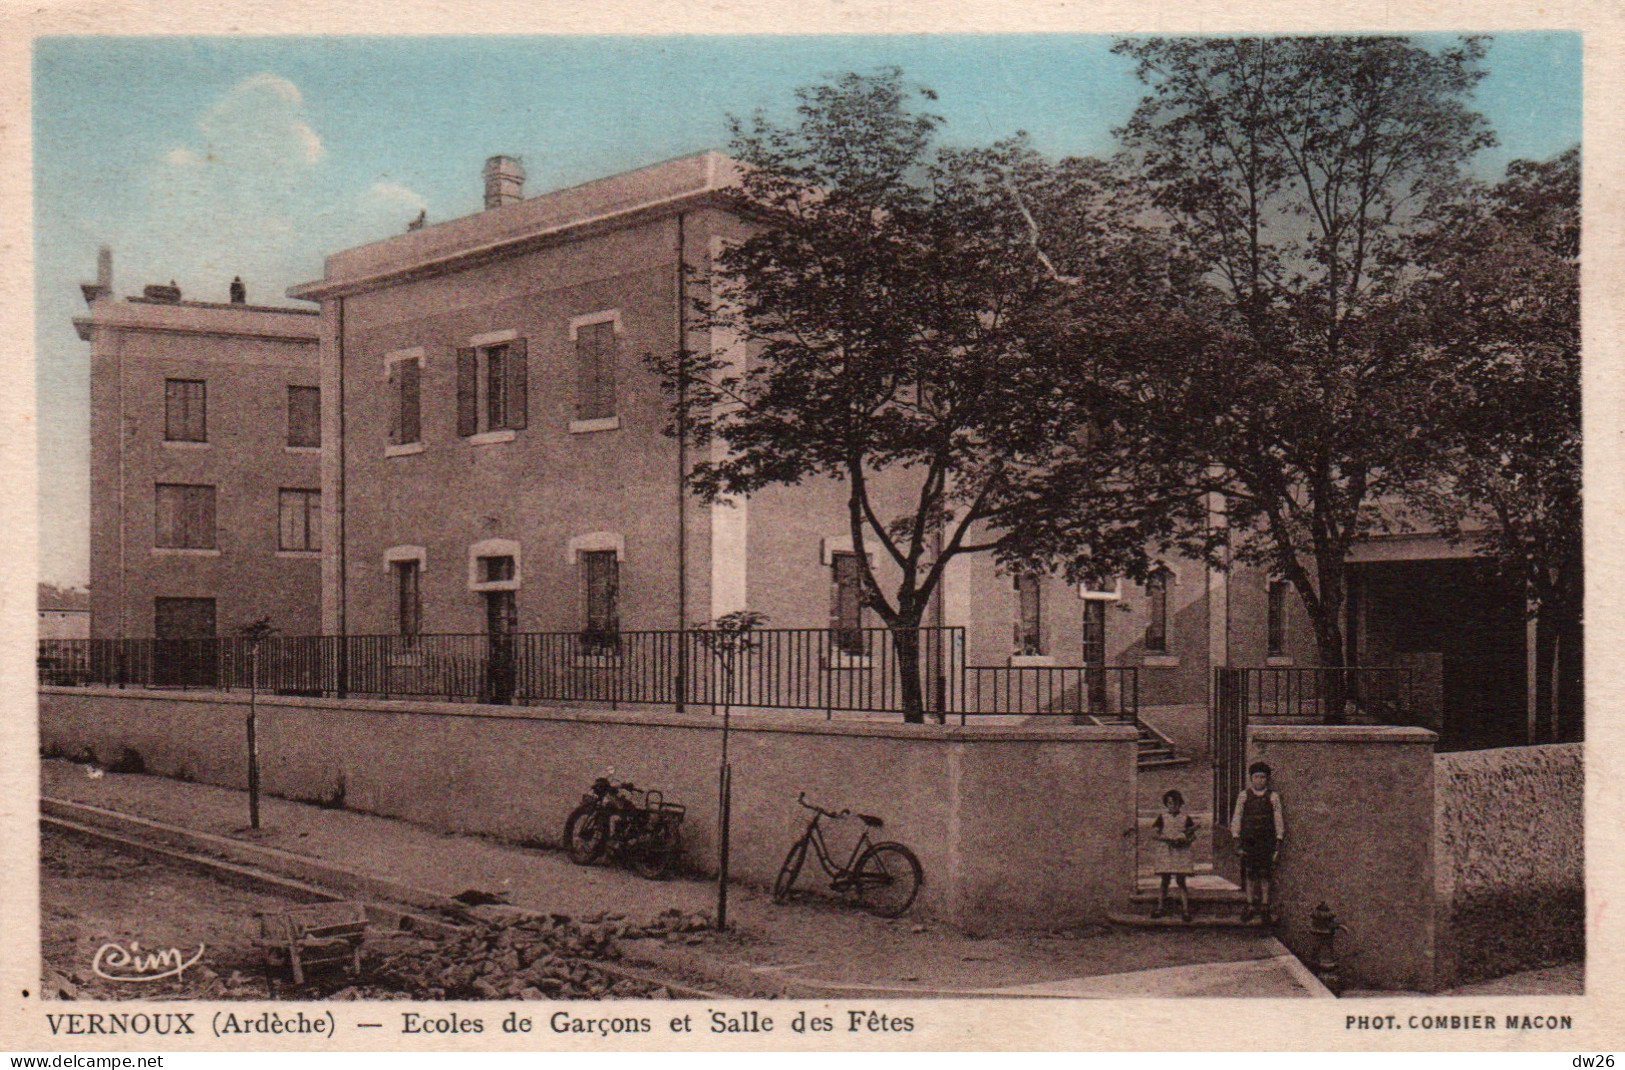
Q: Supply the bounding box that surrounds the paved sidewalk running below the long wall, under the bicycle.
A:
[41,761,1326,998]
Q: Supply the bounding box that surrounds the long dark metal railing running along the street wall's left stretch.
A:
[39,628,964,714]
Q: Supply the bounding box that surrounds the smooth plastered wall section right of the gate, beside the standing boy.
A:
[1248,725,1437,990]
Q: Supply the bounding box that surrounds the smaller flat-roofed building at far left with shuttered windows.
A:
[73,249,322,639]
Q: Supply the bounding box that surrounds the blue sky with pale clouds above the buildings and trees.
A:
[34,33,1581,584]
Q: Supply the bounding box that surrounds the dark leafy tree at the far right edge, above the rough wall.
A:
[1407,146,1584,740]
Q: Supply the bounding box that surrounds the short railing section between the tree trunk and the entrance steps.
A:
[956,665,1139,724]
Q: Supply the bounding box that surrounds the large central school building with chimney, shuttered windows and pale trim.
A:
[289,153,1313,715]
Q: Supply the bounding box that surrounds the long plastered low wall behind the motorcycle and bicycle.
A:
[39,688,1136,932]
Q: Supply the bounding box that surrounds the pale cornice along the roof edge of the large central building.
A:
[288,151,738,301]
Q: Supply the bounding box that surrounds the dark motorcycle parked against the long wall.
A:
[564,777,686,880]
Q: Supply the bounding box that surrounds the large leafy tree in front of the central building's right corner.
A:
[653,70,1176,722]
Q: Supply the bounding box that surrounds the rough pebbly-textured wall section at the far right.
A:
[1433,743,1586,984]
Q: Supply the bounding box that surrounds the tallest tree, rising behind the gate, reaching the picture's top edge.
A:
[1115,37,1493,717]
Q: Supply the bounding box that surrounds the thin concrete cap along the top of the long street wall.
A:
[39,686,1139,743]
